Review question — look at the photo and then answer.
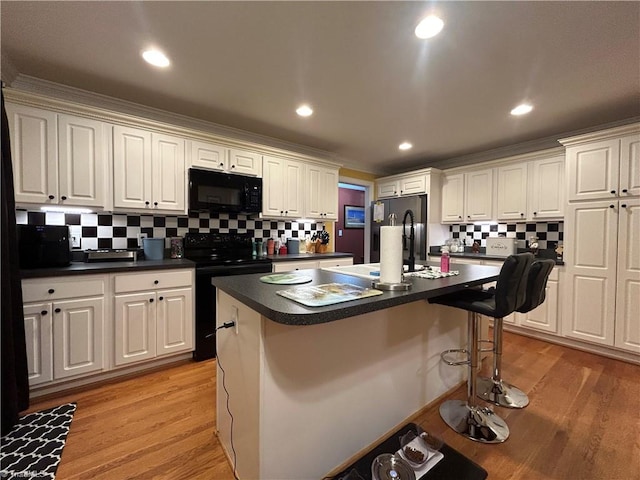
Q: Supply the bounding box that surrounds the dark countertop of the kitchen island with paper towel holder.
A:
[211,262,500,325]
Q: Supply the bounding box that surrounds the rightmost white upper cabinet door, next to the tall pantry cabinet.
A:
[529,157,565,220]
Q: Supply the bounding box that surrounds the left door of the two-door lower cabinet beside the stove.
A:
[114,292,157,365]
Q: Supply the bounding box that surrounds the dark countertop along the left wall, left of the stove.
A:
[20,258,196,278]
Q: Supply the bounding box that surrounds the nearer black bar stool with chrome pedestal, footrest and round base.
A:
[429,253,533,443]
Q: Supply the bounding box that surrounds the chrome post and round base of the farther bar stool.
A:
[477,318,529,408]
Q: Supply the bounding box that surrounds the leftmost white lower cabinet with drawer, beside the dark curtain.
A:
[22,275,106,387]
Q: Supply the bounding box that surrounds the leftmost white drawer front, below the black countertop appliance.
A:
[22,275,105,303]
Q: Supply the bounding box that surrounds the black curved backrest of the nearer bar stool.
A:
[495,253,534,318]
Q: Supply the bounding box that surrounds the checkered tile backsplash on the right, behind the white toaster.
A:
[449,222,564,249]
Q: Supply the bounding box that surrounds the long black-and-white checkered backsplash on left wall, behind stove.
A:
[16,210,322,250]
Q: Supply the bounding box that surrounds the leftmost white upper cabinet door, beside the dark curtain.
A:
[6,103,58,204]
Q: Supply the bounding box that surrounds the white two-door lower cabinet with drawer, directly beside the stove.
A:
[114,270,194,366]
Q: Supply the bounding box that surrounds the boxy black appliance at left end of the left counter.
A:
[17,225,71,268]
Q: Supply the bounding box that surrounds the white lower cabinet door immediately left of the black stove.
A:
[156,288,194,356]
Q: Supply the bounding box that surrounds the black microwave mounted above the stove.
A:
[189,168,262,214]
